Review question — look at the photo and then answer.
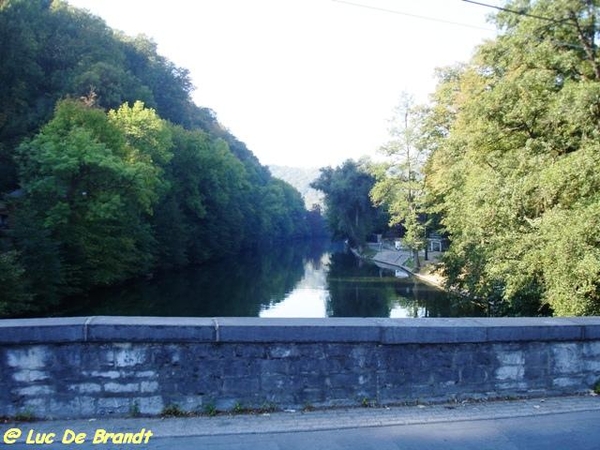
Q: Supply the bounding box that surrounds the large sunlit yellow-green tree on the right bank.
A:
[426,0,600,315]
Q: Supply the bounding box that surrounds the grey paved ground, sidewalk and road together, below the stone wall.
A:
[0,396,600,450]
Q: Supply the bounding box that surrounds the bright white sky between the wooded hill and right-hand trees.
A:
[68,0,501,167]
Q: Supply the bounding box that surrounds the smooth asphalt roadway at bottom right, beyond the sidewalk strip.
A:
[158,411,600,450]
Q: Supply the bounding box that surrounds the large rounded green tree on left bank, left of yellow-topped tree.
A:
[19,101,159,289]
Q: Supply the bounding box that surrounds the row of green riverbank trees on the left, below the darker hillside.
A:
[7,100,307,312]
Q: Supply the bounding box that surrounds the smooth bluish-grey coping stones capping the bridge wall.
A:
[0,316,600,345]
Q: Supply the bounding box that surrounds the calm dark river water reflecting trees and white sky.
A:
[61,241,481,317]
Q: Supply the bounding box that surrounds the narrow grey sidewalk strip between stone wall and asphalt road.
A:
[0,395,600,438]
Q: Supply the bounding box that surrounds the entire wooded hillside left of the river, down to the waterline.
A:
[0,0,310,316]
